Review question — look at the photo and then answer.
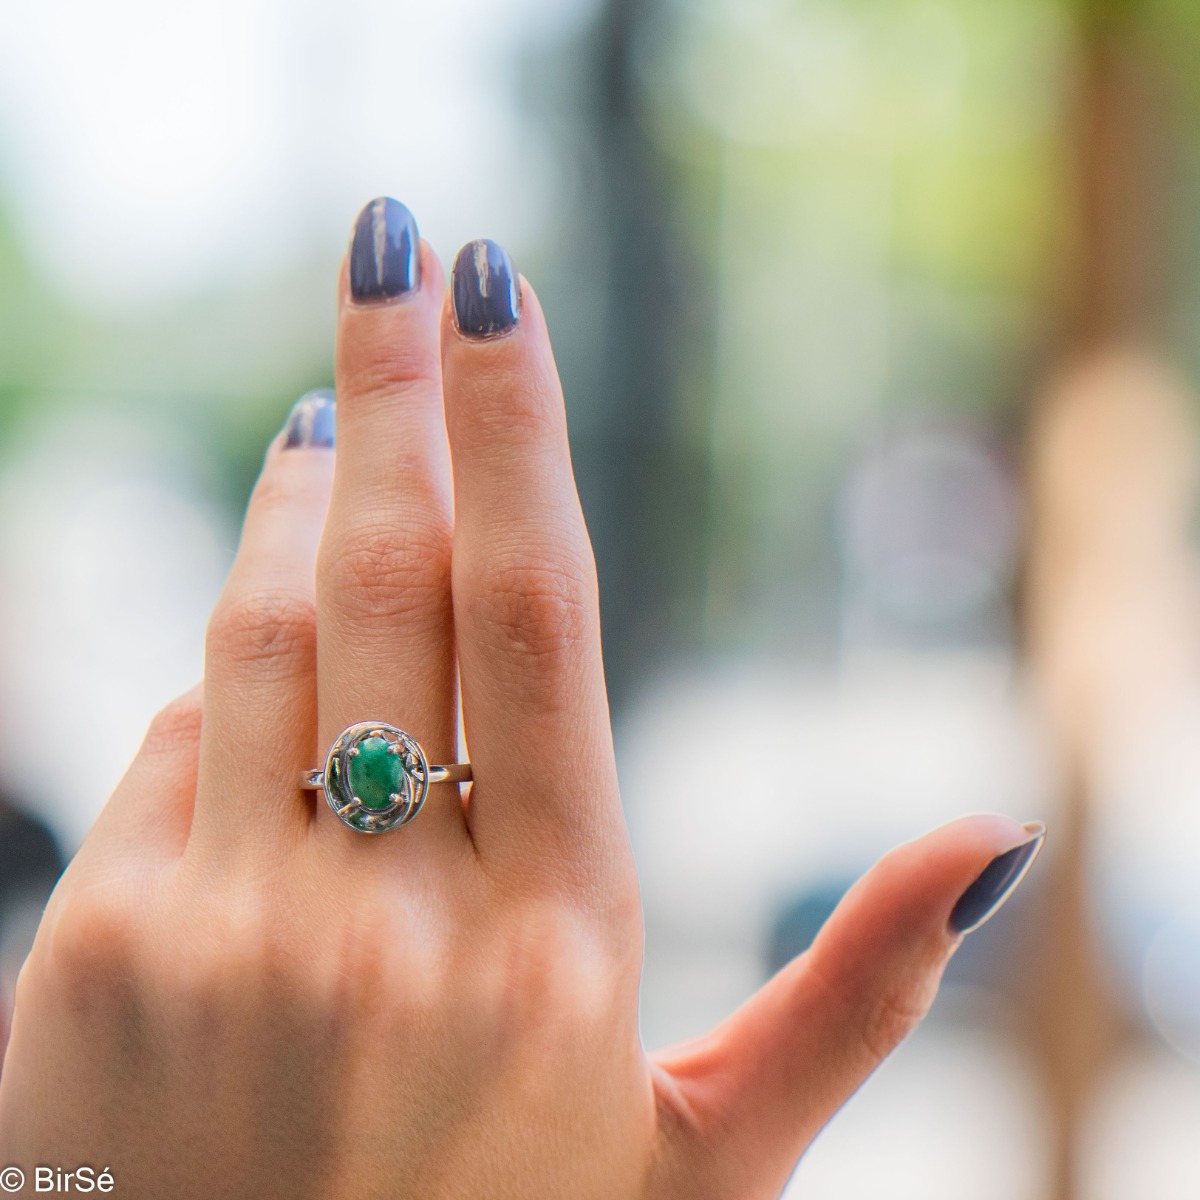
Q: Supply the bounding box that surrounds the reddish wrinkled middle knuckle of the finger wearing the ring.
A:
[320,523,450,624]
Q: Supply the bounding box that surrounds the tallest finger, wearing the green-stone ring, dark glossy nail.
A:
[317,199,468,857]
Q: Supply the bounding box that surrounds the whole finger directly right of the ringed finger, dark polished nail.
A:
[442,241,629,882]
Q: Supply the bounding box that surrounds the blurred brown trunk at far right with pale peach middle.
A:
[1024,4,1193,1200]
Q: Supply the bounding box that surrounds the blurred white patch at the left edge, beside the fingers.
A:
[0,415,232,847]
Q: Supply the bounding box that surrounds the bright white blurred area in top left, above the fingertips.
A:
[0,0,596,307]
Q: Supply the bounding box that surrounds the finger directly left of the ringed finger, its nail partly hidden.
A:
[190,391,334,856]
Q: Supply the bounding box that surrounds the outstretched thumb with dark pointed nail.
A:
[652,816,1045,1200]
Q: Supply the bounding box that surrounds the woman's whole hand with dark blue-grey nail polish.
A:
[0,200,1040,1200]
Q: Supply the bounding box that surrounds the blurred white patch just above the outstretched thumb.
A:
[618,654,1050,944]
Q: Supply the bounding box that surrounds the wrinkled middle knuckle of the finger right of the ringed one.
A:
[469,554,596,671]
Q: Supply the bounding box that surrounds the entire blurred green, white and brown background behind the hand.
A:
[7,0,1200,1200]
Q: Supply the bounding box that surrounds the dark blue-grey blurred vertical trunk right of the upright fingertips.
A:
[568,0,710,707]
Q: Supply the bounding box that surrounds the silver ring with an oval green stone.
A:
[300,721,472,833]
